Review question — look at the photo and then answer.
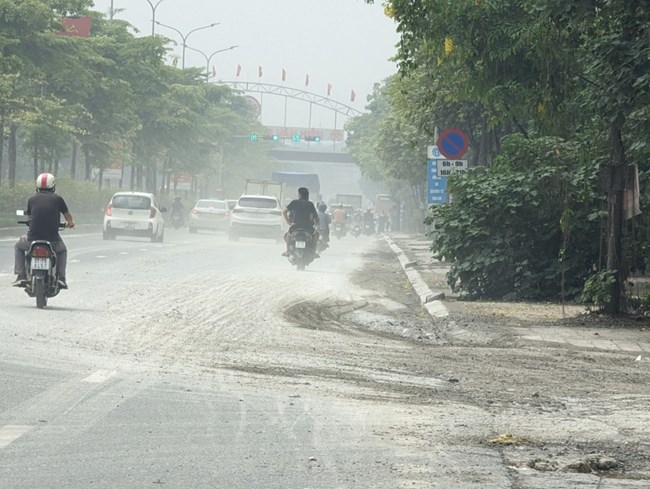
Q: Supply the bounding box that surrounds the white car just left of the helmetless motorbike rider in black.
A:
[228,195,286,241]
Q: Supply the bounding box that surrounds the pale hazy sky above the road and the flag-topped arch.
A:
[88,0,399,129]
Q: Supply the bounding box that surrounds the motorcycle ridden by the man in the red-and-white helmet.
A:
[16,211,65,309]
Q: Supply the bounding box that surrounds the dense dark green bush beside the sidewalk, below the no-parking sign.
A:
[428,136,603,299]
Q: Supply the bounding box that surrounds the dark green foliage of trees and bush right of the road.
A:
[360,0,650,304]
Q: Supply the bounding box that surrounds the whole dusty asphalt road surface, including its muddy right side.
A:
[0,230,650,489]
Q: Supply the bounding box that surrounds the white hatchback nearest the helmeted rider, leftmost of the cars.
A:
[102,192,167,243]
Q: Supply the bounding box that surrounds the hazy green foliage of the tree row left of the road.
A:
[0,0,267,192]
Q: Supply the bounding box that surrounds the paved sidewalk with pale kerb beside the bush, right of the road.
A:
[384,234,650,354]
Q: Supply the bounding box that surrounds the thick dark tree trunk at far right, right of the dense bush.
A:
[605,124,627,314]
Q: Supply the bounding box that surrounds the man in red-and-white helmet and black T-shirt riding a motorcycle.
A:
[11,173,74,289]
